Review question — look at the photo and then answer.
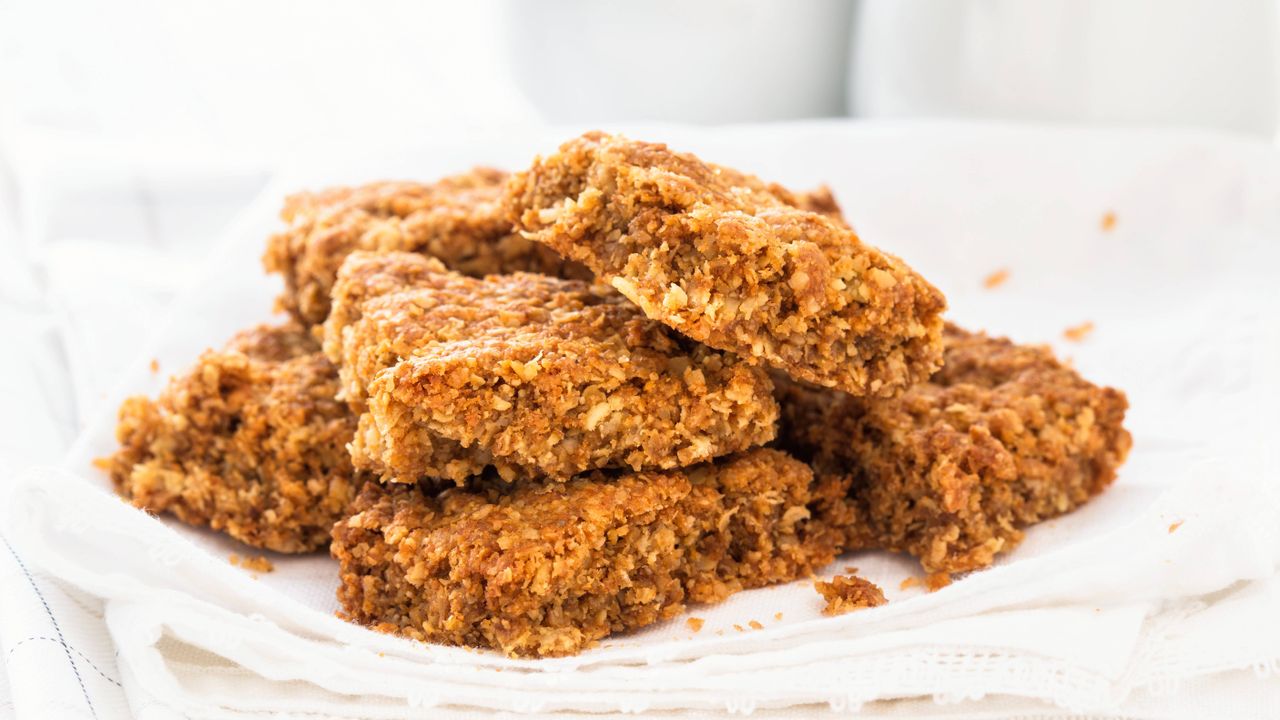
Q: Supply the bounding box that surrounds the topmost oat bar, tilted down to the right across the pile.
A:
[503,133,946,396]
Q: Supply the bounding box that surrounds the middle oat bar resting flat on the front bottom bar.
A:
[325,252,777,483]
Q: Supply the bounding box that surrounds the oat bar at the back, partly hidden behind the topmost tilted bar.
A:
[271,168,591,324]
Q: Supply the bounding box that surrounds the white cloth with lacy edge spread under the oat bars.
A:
[0,123,1280,717]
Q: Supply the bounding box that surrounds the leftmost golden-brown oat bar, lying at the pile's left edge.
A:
[97,323,358,552]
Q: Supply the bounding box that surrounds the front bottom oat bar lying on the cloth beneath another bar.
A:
[332,448,837,656]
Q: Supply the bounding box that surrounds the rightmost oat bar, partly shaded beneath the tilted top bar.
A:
[776,325,1132,573]
